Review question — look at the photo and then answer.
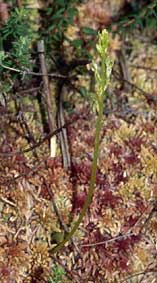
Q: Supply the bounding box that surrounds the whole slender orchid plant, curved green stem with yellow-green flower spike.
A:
[49,30,113,254]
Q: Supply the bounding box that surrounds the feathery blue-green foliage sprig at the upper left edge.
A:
[0,8,33,74]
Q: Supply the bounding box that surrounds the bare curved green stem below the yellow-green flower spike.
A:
[50,99,104,253]
